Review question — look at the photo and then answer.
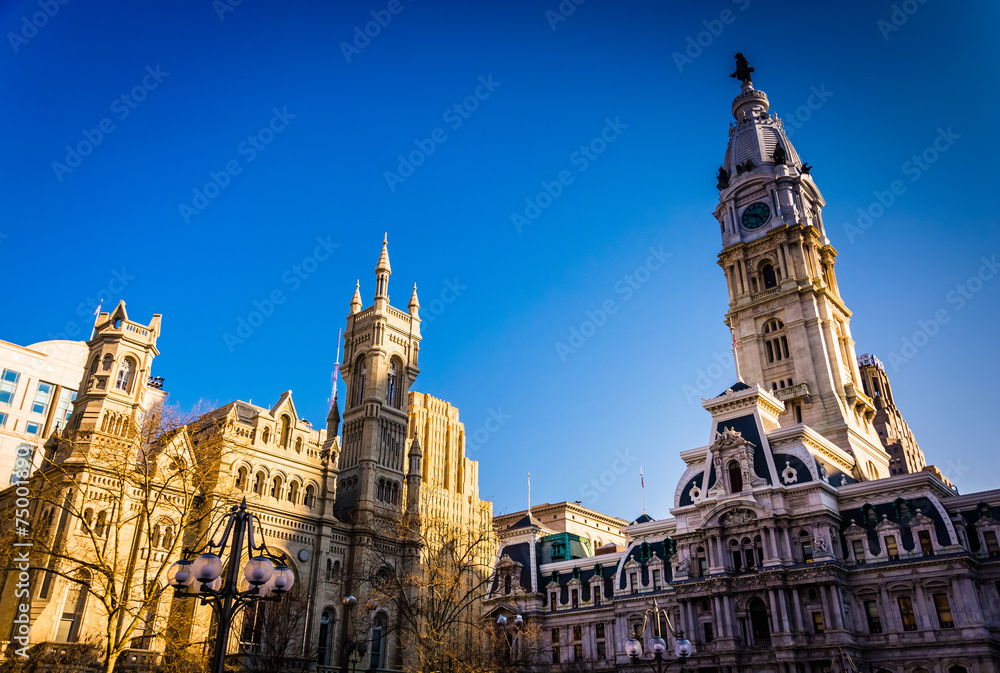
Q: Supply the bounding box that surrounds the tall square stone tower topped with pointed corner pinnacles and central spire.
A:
[334,240,420,523]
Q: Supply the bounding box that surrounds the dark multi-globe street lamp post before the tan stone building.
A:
[167,498,295,673]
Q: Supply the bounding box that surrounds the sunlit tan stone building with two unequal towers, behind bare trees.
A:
[0,241,492,670]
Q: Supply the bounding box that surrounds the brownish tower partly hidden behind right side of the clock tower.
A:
[858,353,927,474]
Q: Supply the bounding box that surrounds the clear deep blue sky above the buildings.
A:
[0,0,1000,519]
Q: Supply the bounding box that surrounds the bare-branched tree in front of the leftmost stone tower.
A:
[0,406,240,673]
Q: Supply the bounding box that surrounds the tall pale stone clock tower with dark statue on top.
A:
[715,56,889,480]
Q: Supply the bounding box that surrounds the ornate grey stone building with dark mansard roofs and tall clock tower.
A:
[486,71,1000,673]
